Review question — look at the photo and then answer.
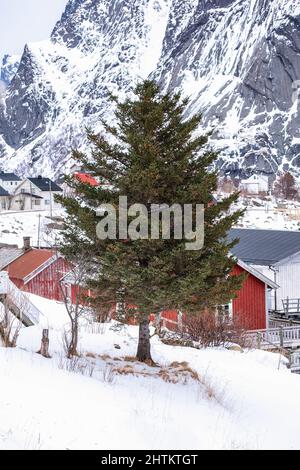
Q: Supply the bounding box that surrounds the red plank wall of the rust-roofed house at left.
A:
[11,258,69,301]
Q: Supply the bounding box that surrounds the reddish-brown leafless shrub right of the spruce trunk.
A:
[185,311,246,348]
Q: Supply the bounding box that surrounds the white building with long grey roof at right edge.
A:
[229,229,300,314]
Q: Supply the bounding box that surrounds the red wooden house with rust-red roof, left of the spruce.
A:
[0,237,70,300]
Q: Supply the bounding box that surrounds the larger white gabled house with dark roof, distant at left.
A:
[11,176,62,212]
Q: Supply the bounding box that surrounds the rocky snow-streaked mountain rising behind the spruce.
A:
[0,0,300,176]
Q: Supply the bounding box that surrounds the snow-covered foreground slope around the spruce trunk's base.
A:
[0,295,300,450]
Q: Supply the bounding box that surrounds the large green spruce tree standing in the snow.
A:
[58,81,242,361]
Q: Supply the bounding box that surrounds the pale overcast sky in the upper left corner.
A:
[0,0,67,58]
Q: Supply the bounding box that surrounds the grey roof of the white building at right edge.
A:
[228,229,300,266]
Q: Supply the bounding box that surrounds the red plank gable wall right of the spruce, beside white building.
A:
[232,266,267,330]
